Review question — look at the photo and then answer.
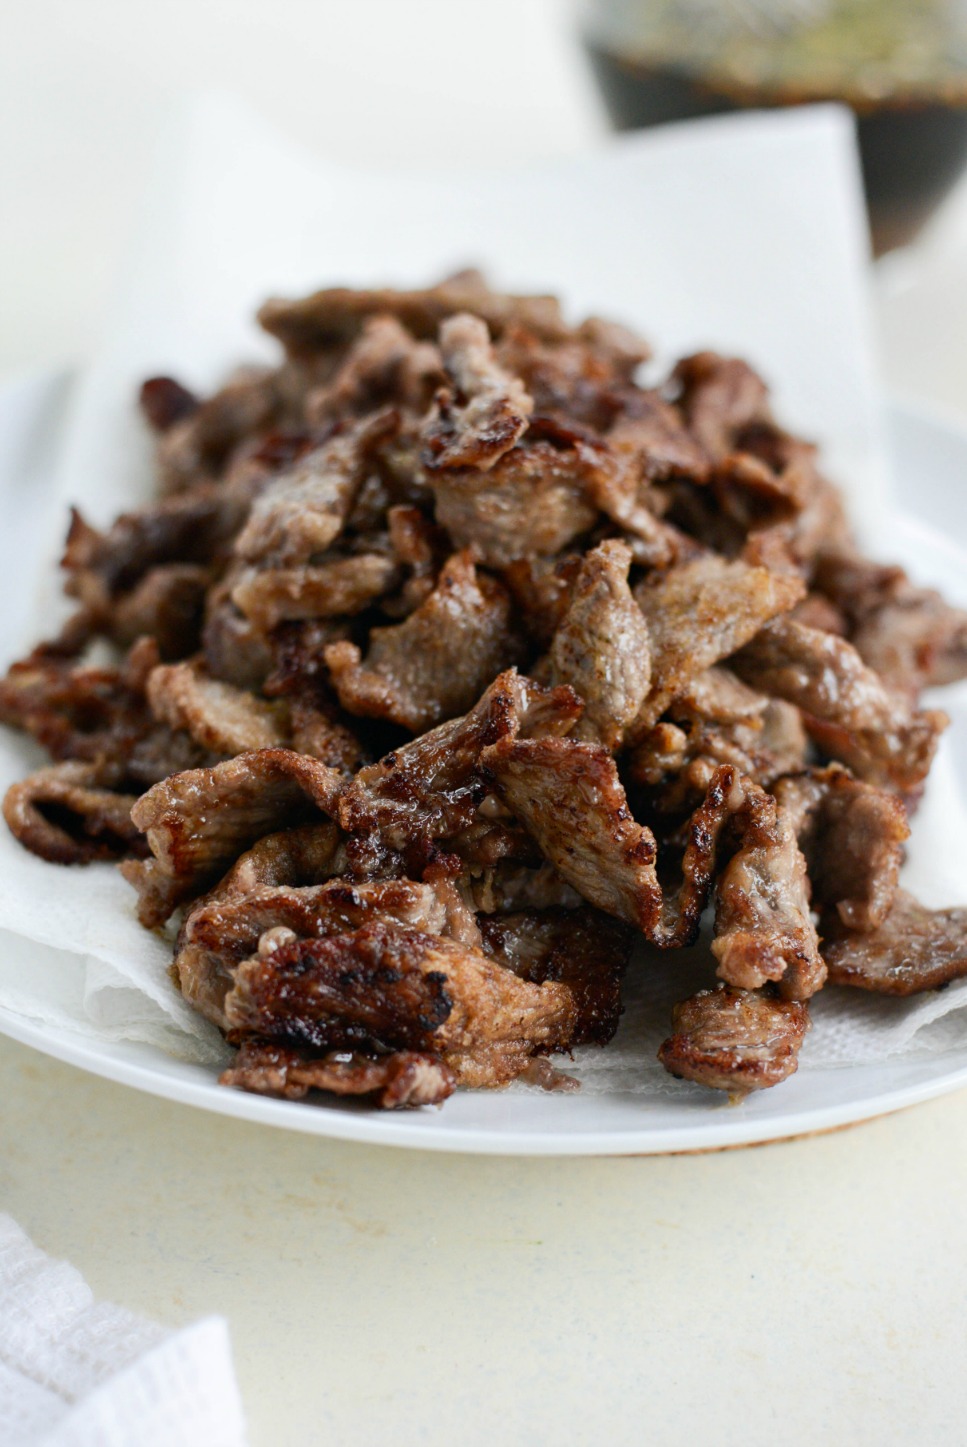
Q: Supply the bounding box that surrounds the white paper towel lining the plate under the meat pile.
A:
[0,90,967,1088]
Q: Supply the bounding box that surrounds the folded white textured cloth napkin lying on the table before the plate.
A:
[0,1215,248,1447]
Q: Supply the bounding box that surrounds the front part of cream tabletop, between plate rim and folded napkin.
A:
[0,1040,967,1447]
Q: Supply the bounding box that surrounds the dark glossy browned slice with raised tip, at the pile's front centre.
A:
[339,671,582,865]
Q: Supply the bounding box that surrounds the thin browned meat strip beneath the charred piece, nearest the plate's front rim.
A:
[219,1040,456,1110]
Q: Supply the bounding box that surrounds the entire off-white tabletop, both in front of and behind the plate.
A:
[0,0,967,1447]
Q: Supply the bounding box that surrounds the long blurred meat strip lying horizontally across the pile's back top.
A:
[259,272,567,356]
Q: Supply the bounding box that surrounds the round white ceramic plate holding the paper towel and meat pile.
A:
[0,378,967,1155]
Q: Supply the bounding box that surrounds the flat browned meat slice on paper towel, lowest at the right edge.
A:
[824,890,967,996]
